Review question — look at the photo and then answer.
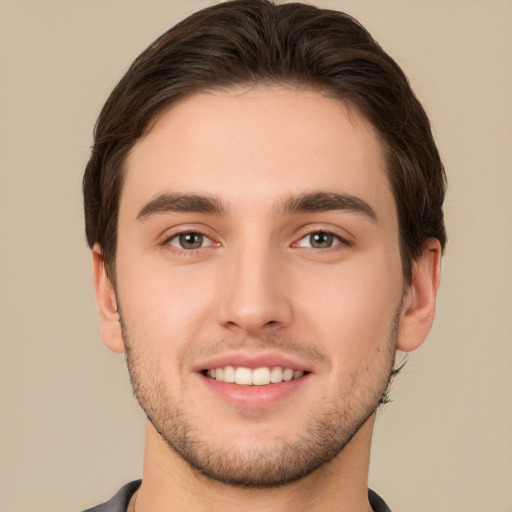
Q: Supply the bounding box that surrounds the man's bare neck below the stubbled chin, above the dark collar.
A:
[136,415,375,512]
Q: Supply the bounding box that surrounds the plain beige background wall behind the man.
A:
[0,0,512,512]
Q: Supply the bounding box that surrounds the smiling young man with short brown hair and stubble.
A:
[84,0,445,512]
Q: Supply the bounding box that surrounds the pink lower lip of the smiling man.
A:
[200,373,311,409]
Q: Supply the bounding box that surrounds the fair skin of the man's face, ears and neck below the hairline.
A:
[93,87,441,512]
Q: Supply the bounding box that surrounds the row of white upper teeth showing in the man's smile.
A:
[206,366,304,386]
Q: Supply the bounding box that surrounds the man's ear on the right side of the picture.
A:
[397,238,441,352]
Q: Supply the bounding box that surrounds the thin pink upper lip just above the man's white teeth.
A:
[195,351,312,372]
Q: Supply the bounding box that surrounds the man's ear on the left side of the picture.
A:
[92,244,125,354]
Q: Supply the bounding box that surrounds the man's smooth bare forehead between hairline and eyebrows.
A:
[120,87,395,224]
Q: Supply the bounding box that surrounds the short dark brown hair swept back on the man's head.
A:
[83,0,446,281]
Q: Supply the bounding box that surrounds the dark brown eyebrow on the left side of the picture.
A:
[137,194,226,220]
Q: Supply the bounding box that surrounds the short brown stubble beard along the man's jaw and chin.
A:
[121,311,400,488]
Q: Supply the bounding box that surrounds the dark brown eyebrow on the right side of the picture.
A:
[276,191,377,222]
